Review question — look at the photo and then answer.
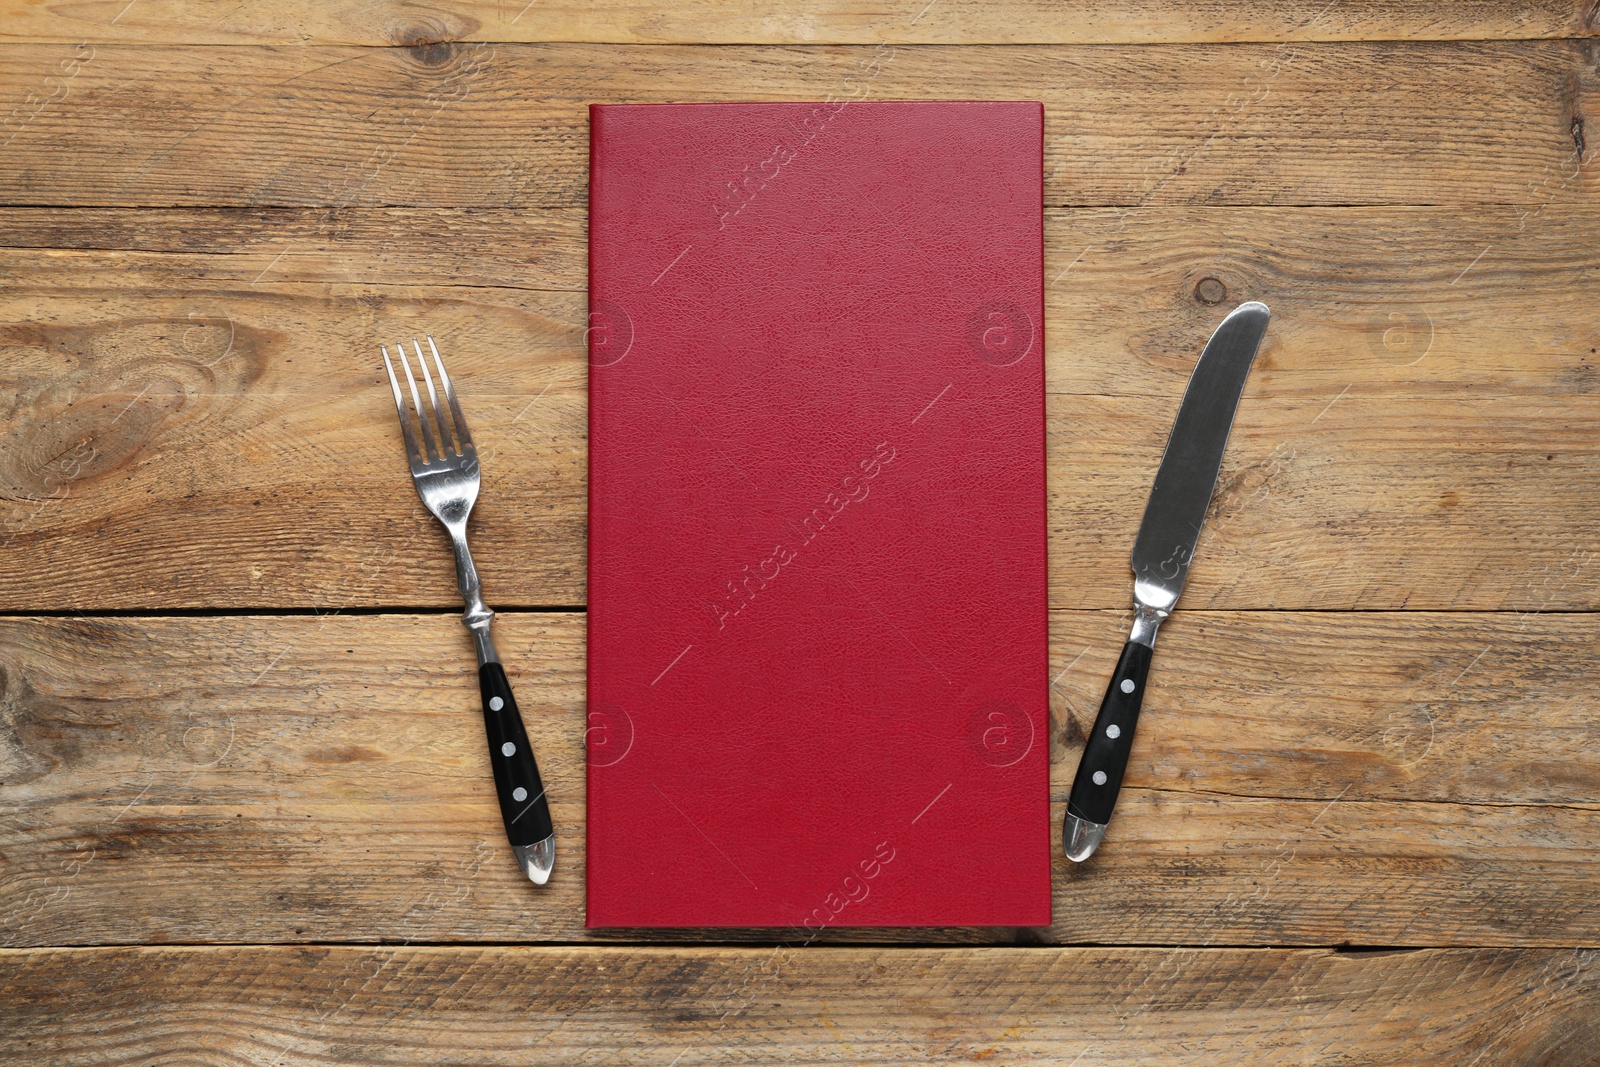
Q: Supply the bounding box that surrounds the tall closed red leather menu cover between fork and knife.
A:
[586,102,1054,931]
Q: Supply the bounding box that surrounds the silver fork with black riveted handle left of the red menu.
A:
[378,336,555,885]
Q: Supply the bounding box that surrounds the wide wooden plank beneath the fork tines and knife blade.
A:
[0,204,1600,611]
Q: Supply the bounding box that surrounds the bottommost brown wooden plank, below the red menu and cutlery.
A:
[0,945,1600,1067]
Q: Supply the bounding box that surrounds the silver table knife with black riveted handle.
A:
[1061,301,1272,862]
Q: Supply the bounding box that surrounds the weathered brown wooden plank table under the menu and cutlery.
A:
[0,0,1600,1067]
